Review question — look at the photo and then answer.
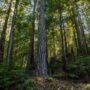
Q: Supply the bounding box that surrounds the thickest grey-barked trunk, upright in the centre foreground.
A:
[37,0,47,76]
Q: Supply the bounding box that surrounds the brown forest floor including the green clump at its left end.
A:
[15,77,90,90]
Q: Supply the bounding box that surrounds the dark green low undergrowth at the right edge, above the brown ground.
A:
[68,57,90,78]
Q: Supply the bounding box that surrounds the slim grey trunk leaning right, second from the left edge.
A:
[6,0,19,67]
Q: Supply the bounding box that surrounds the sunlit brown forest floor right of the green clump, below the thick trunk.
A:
[32,78,90,90]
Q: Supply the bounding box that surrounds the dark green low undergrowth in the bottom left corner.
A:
[0,69,28,89]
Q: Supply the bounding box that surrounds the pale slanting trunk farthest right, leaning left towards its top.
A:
[77,5,88,55]
